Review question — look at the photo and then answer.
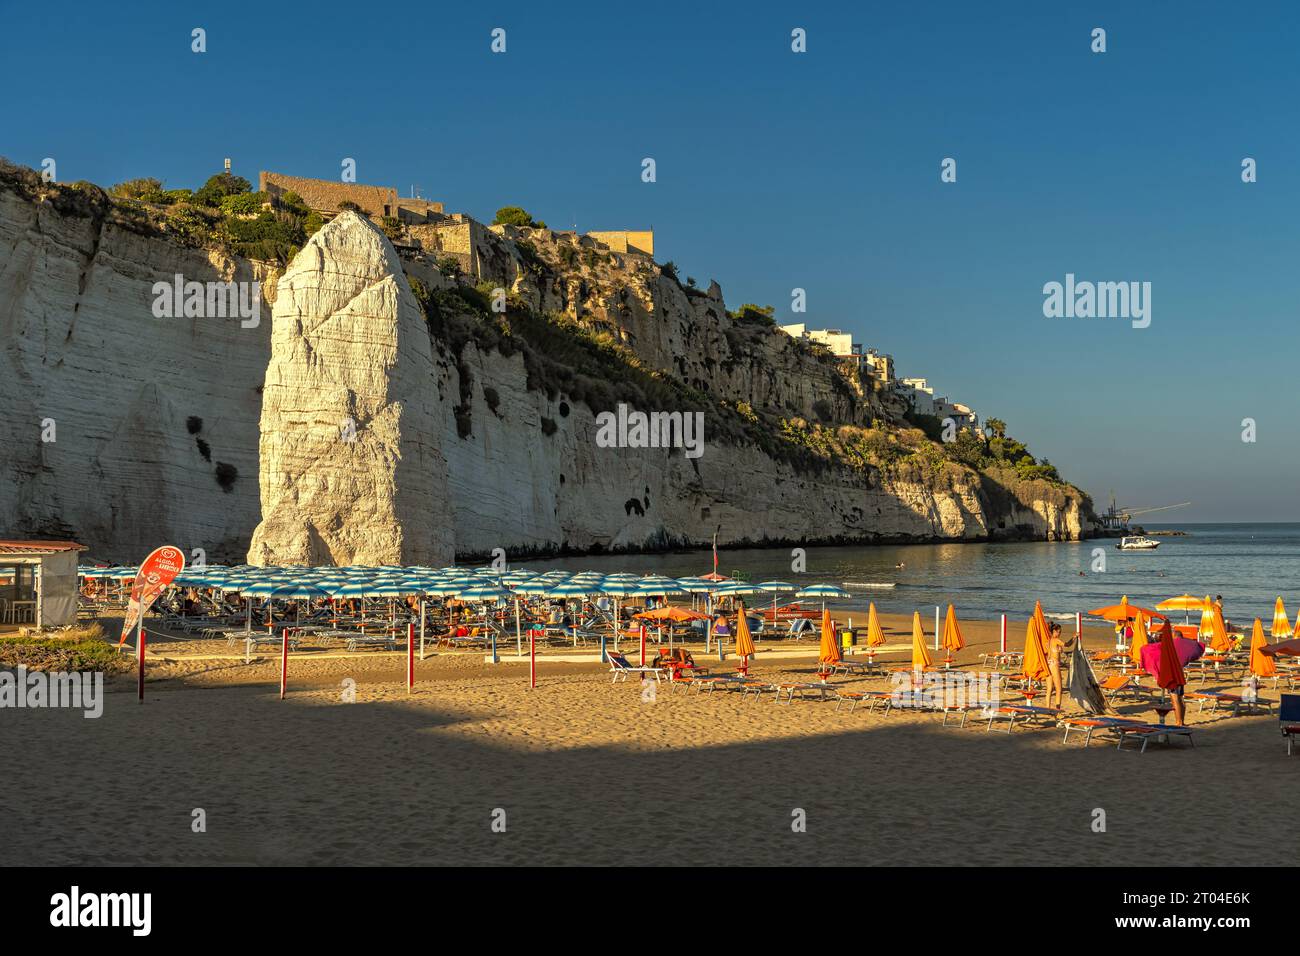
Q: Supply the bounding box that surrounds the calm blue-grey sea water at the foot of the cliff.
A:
[525,524,1300,627]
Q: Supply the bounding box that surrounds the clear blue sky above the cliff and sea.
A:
[0,0,1300,520]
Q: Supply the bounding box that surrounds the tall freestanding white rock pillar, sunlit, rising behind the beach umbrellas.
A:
[248,212,452,564]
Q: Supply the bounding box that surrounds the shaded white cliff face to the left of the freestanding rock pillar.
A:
[0,189,274,563]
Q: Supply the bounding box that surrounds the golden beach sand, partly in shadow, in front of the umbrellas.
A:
[0,615,1300,866]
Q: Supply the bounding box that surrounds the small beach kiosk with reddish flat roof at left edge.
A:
[0,540,86,627]
